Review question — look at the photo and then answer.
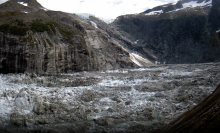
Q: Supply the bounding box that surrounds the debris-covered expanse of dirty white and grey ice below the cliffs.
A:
[0,63,220,132]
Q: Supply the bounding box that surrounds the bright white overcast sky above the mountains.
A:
[0,0,177,19]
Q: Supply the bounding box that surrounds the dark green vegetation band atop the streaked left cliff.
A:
[0,18,86,49]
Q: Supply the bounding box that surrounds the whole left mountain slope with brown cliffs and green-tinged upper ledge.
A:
[0,0,152,74]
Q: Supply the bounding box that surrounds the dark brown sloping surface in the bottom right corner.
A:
[157,86,220,133]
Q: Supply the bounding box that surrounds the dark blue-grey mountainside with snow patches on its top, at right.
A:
[113,0,220,63]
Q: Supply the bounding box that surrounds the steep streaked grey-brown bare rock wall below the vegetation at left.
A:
[0,33,98,74]
